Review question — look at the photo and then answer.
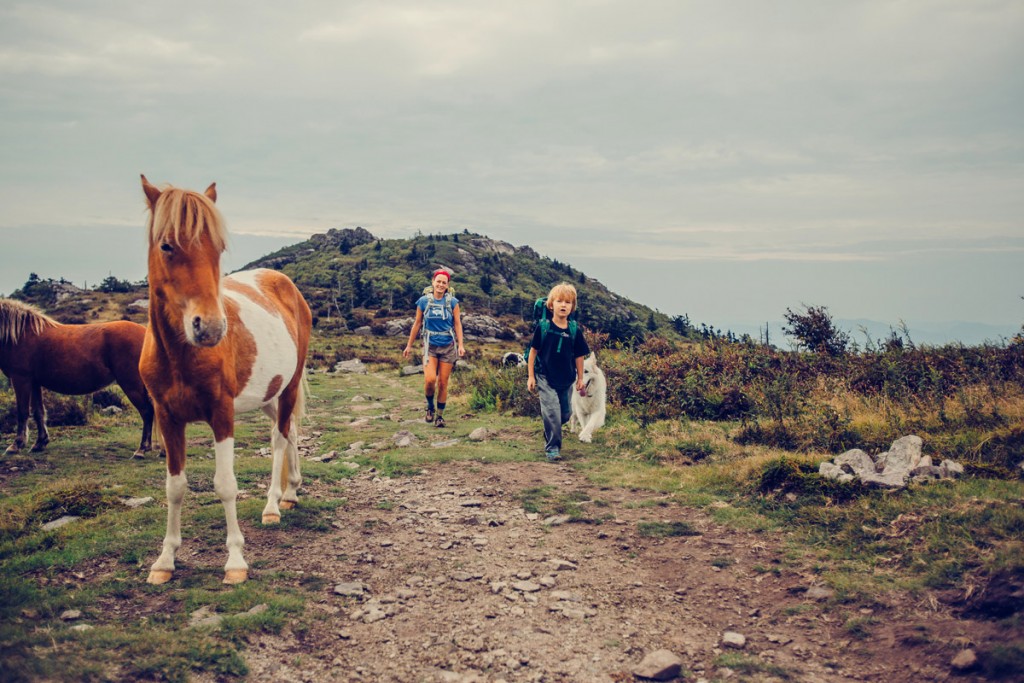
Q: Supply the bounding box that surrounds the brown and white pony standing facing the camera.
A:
[139,175,312,584]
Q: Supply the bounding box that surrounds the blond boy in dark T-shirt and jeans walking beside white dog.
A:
[526,283,590,461]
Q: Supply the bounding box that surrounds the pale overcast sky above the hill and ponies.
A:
[0,0,1024,329]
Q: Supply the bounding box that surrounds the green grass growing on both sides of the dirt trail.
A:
[0,340,1024,681]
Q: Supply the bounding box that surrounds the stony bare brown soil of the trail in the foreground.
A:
[176,462,1021,683]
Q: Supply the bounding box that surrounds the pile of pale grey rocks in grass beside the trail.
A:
[818,434,964,488]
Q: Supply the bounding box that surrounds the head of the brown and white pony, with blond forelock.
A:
[142,176,227,346]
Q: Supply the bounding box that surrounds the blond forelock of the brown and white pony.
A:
[150,187,227,252]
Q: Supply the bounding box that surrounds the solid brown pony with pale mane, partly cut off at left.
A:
[0,299,153,458]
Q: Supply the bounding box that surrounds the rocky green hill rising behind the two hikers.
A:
[245,227,674,341]
